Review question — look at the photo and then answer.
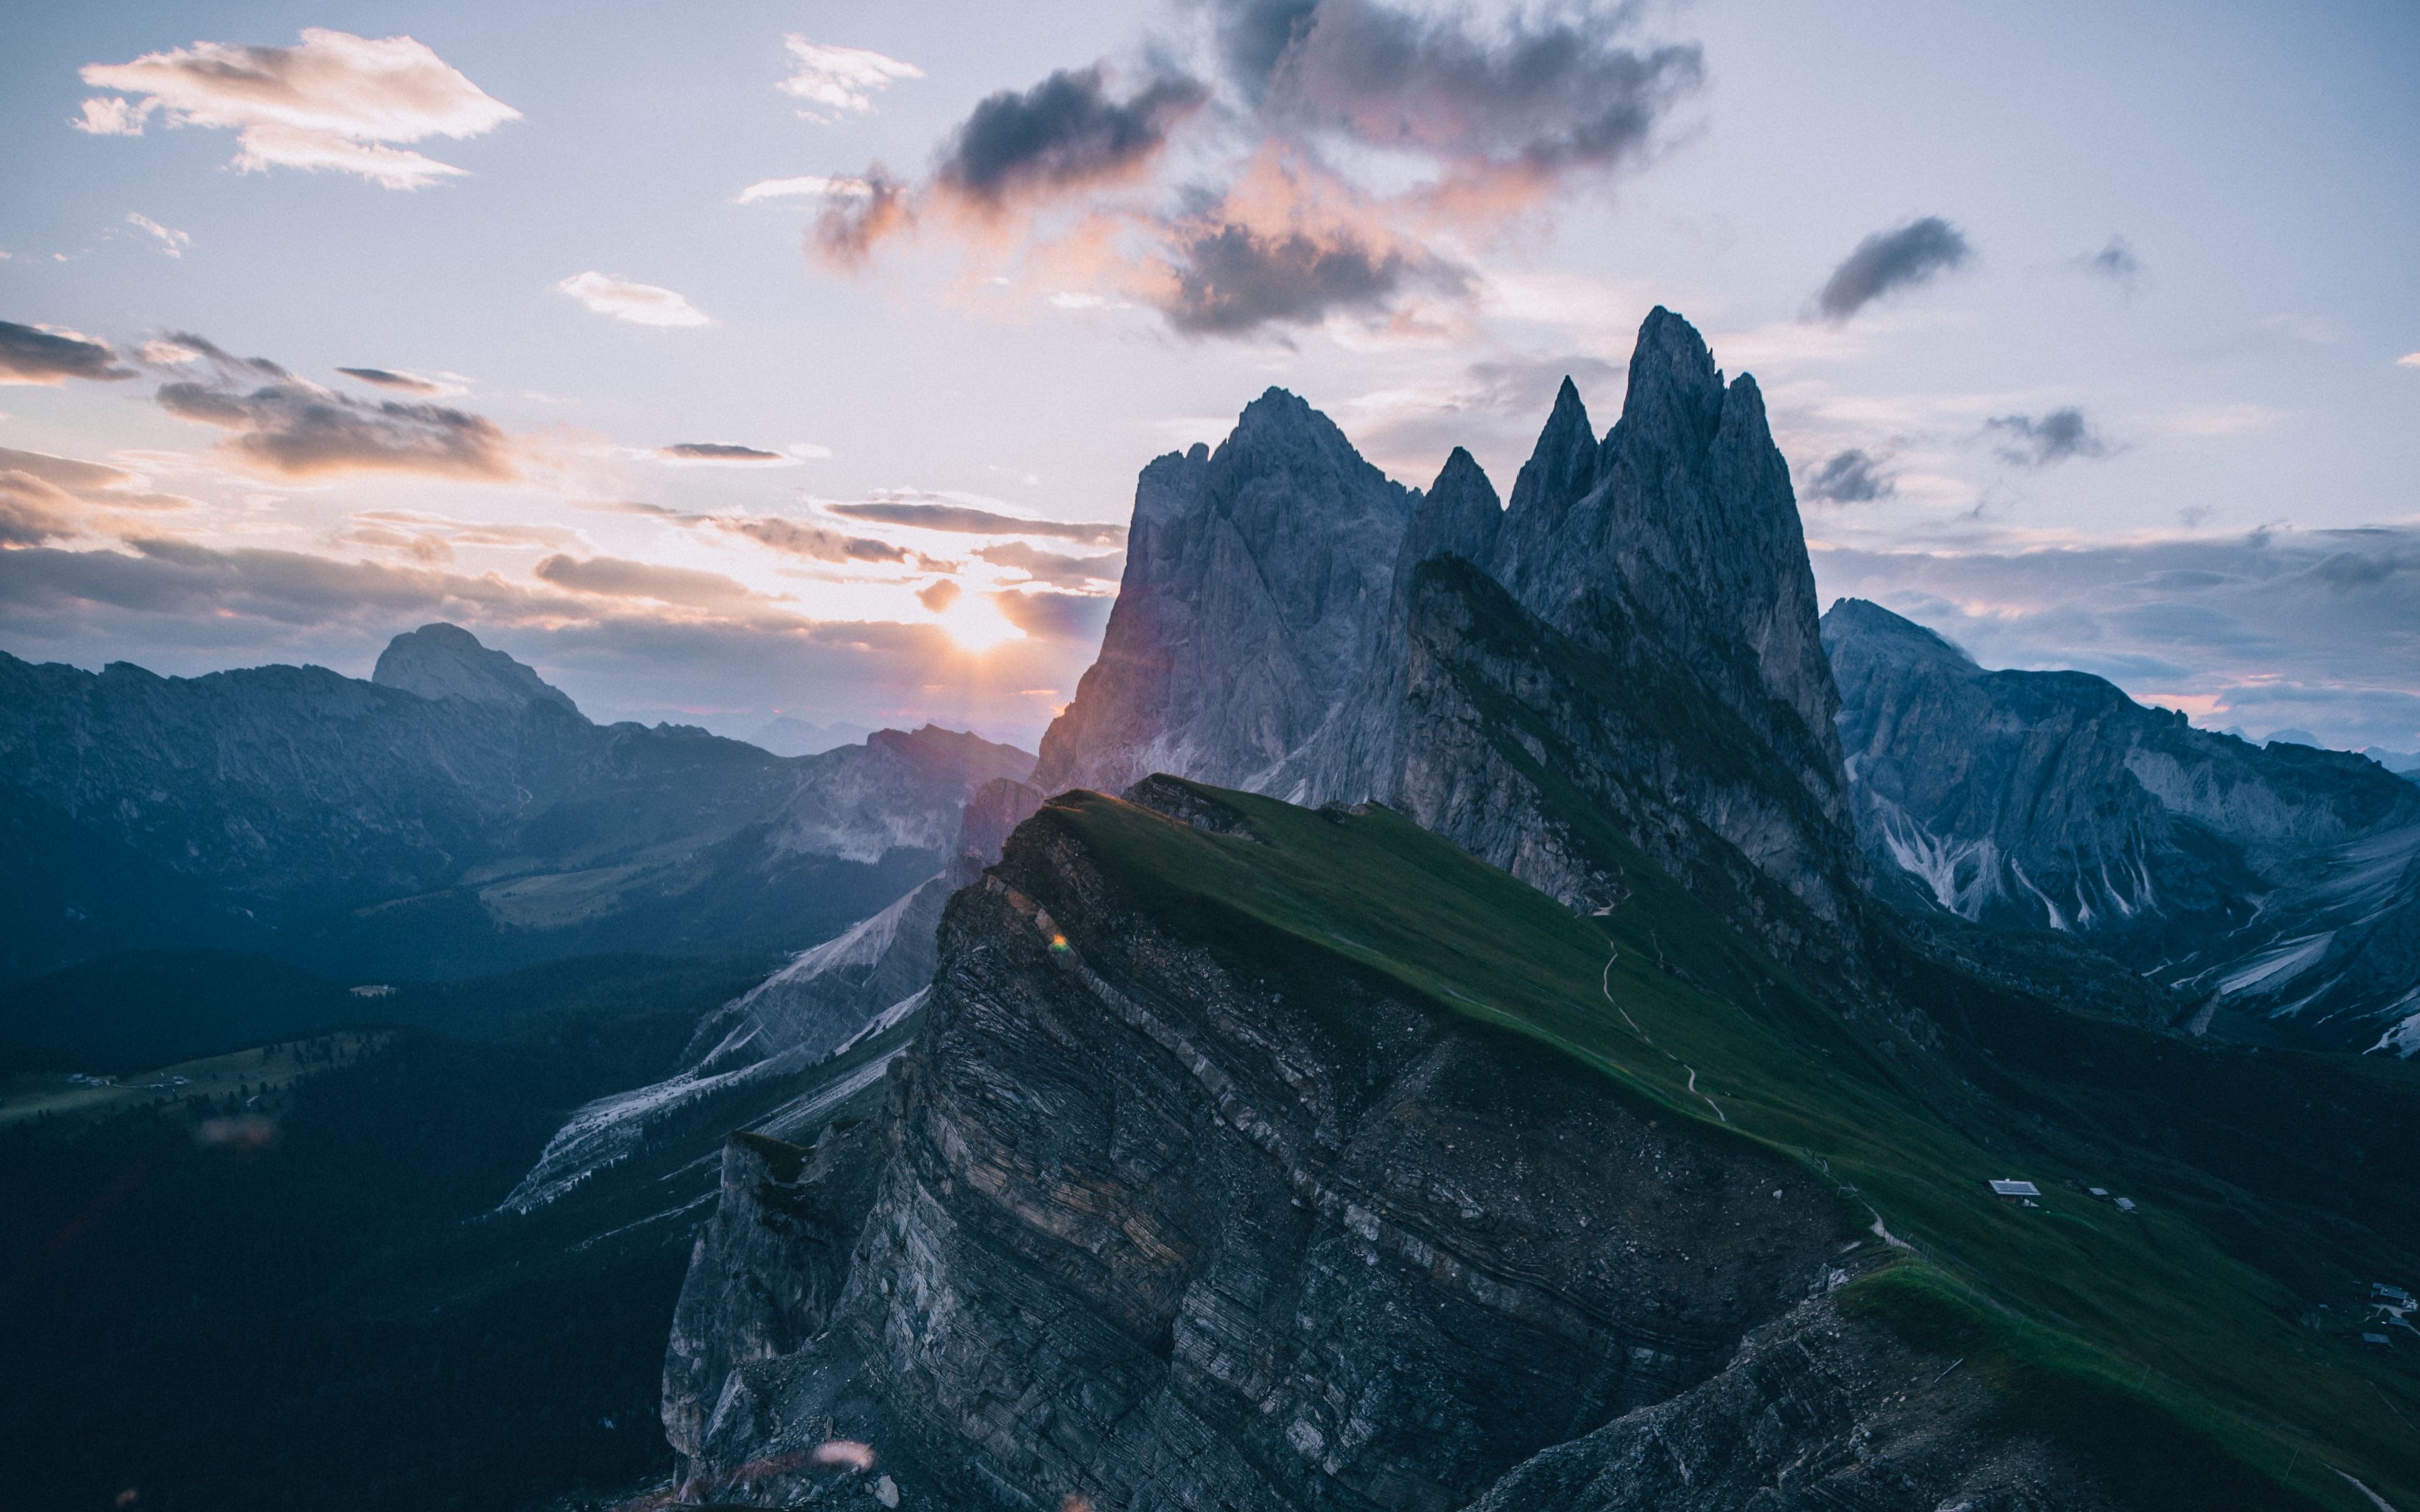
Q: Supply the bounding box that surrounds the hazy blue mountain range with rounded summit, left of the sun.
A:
[0,624,1031,980]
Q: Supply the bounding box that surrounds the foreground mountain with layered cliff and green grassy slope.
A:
[663,777,2420,1512]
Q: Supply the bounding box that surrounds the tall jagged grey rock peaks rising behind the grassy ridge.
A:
[1034,310,1864,960]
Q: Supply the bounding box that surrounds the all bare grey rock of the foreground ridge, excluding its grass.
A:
[663,784,2139,1512]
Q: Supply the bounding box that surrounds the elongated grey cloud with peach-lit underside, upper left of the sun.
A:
[158,331,516,481]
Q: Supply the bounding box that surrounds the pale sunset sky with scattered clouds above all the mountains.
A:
[0,0,2420,752]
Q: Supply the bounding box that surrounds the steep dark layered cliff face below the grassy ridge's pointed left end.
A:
[666,784,1853,1509]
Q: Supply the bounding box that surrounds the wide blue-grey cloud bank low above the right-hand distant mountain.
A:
[1812,527,2420,750]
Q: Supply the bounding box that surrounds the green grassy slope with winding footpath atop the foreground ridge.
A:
[1048,784,2420,1512]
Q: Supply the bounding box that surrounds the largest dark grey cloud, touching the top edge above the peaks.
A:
[1218,0,1703,172]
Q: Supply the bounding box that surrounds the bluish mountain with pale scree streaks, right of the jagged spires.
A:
[1823,600,2420,1055]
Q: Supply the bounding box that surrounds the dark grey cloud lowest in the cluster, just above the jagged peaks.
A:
[1159,222,1464,336]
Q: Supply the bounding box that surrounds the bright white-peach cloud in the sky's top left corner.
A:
[75,26,521,189]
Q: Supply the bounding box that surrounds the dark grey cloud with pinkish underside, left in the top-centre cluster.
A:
[934,66,1210,210]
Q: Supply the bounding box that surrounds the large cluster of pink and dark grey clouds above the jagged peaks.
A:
[803,0,1703,343]
